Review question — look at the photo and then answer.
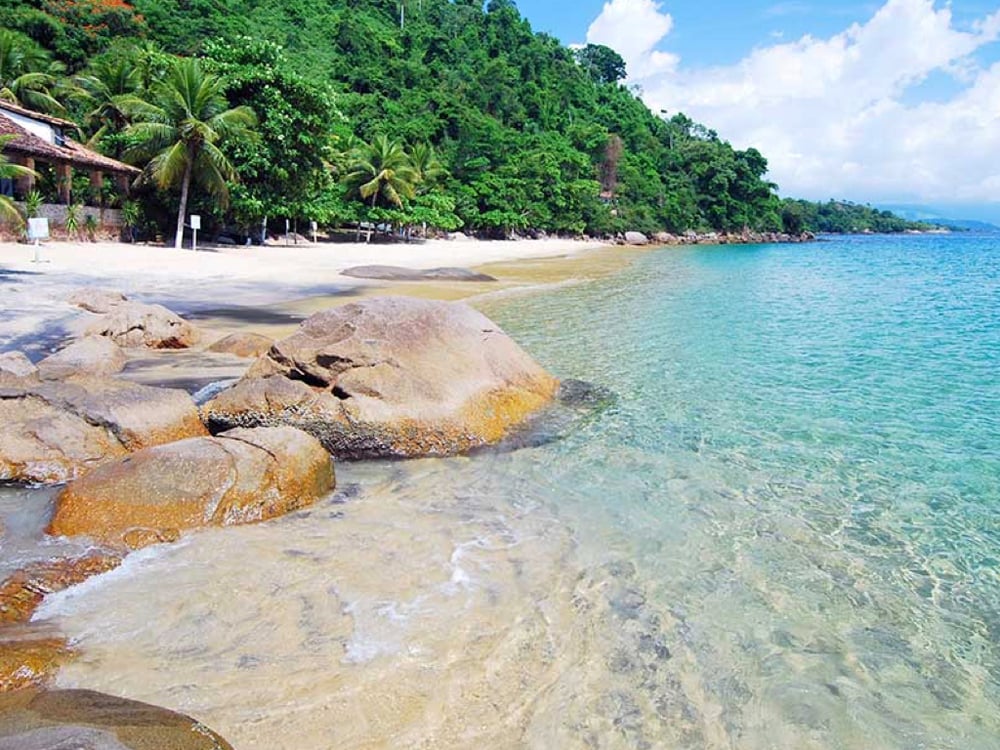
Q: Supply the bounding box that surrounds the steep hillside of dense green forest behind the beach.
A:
[0,0,804,235]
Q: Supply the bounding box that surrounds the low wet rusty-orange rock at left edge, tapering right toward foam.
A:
[0,550,122,622]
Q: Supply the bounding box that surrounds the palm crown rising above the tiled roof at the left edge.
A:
[0,29,65,113]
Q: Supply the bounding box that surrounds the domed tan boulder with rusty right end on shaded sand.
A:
[85,302,200,349]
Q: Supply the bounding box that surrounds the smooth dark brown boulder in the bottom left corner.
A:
[0,690,233,750]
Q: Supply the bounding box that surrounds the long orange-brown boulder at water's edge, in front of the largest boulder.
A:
[48,427,334,549]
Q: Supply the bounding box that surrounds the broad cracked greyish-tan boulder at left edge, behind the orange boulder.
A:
[0,376,206,483]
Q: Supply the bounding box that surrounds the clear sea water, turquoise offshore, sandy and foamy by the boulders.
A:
[31,236,1000,750]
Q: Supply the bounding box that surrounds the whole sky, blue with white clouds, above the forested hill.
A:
[518,0,1000,221]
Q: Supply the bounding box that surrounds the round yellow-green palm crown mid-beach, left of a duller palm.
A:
[344,135,418,208]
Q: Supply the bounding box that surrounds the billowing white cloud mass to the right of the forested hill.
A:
[587,0,1000,202]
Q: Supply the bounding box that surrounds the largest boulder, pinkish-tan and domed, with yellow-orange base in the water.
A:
[202,297,558,458]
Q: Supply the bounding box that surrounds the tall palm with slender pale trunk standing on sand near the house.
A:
[125,59,257,249]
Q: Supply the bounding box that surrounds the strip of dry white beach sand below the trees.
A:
[0,239,602,358]
